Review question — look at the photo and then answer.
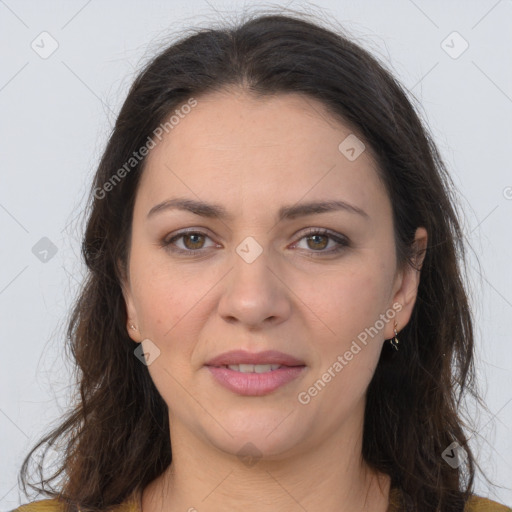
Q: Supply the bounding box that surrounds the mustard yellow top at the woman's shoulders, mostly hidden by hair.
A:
[11,489,512,512]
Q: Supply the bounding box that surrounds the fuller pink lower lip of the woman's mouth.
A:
[207,366,305,396]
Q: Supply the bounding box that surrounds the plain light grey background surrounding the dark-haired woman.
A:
[0,0,512,510]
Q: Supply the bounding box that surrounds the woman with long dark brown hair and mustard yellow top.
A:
[14,8,511,512]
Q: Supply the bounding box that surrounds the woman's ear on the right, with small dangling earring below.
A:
[385,227,428,339]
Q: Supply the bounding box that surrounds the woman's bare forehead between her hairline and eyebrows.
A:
[136,89,387,220]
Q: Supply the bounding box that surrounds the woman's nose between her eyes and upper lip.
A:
[218,245,292,329]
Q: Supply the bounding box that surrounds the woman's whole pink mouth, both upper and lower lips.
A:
[205,350,306,396]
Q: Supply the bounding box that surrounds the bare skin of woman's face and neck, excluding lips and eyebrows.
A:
[123,89,427,512]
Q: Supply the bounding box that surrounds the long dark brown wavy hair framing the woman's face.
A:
[20,11,481,512]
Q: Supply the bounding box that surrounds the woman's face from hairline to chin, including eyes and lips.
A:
[124,90,425,458]
